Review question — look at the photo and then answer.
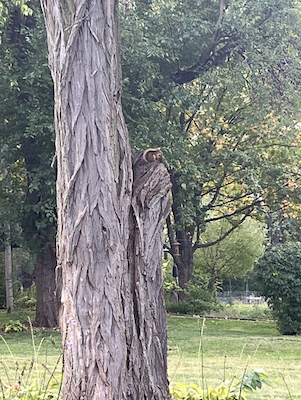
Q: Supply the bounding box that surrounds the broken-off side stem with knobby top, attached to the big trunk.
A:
[127,154,171,400]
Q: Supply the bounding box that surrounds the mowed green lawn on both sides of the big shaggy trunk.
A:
[0,313,301,400]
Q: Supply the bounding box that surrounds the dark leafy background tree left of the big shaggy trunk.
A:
[0,1,58,326]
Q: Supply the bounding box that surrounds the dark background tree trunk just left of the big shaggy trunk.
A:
[34,248,58,328]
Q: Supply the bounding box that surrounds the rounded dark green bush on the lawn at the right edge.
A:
[255,243,301,335]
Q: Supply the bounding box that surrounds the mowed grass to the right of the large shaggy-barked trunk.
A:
[168,316,301,400]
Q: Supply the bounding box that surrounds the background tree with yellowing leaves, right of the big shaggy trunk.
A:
[123,0,300,296]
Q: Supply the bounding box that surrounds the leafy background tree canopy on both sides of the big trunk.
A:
[0,0,300,318]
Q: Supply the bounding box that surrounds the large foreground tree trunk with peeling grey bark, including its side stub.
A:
[41,0,170,400]
